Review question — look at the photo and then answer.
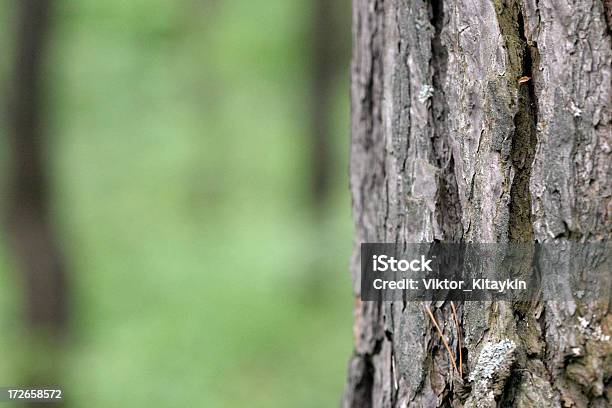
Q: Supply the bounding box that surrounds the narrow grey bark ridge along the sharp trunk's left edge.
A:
[342,0,386,407]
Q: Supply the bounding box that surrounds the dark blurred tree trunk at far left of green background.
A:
[6,0,67,344]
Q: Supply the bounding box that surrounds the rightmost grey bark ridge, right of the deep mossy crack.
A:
[525,0,612,407]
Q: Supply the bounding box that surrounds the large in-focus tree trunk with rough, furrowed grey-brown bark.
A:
[343,0,612,408]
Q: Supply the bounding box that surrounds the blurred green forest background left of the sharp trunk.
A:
[0,0,352,407]
